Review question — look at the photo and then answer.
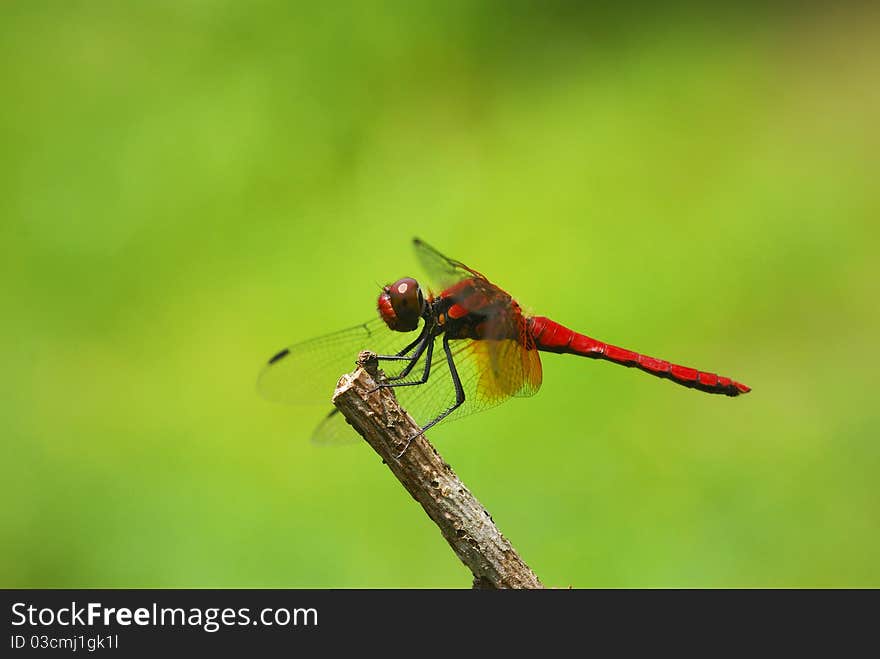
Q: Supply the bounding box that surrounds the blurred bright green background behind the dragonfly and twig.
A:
[0,1,880,587]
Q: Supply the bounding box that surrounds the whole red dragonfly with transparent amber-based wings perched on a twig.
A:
[258,239,750,455]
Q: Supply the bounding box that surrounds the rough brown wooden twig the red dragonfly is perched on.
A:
[333,352,543,588]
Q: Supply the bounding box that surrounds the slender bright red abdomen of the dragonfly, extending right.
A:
[527,316,751,396]
